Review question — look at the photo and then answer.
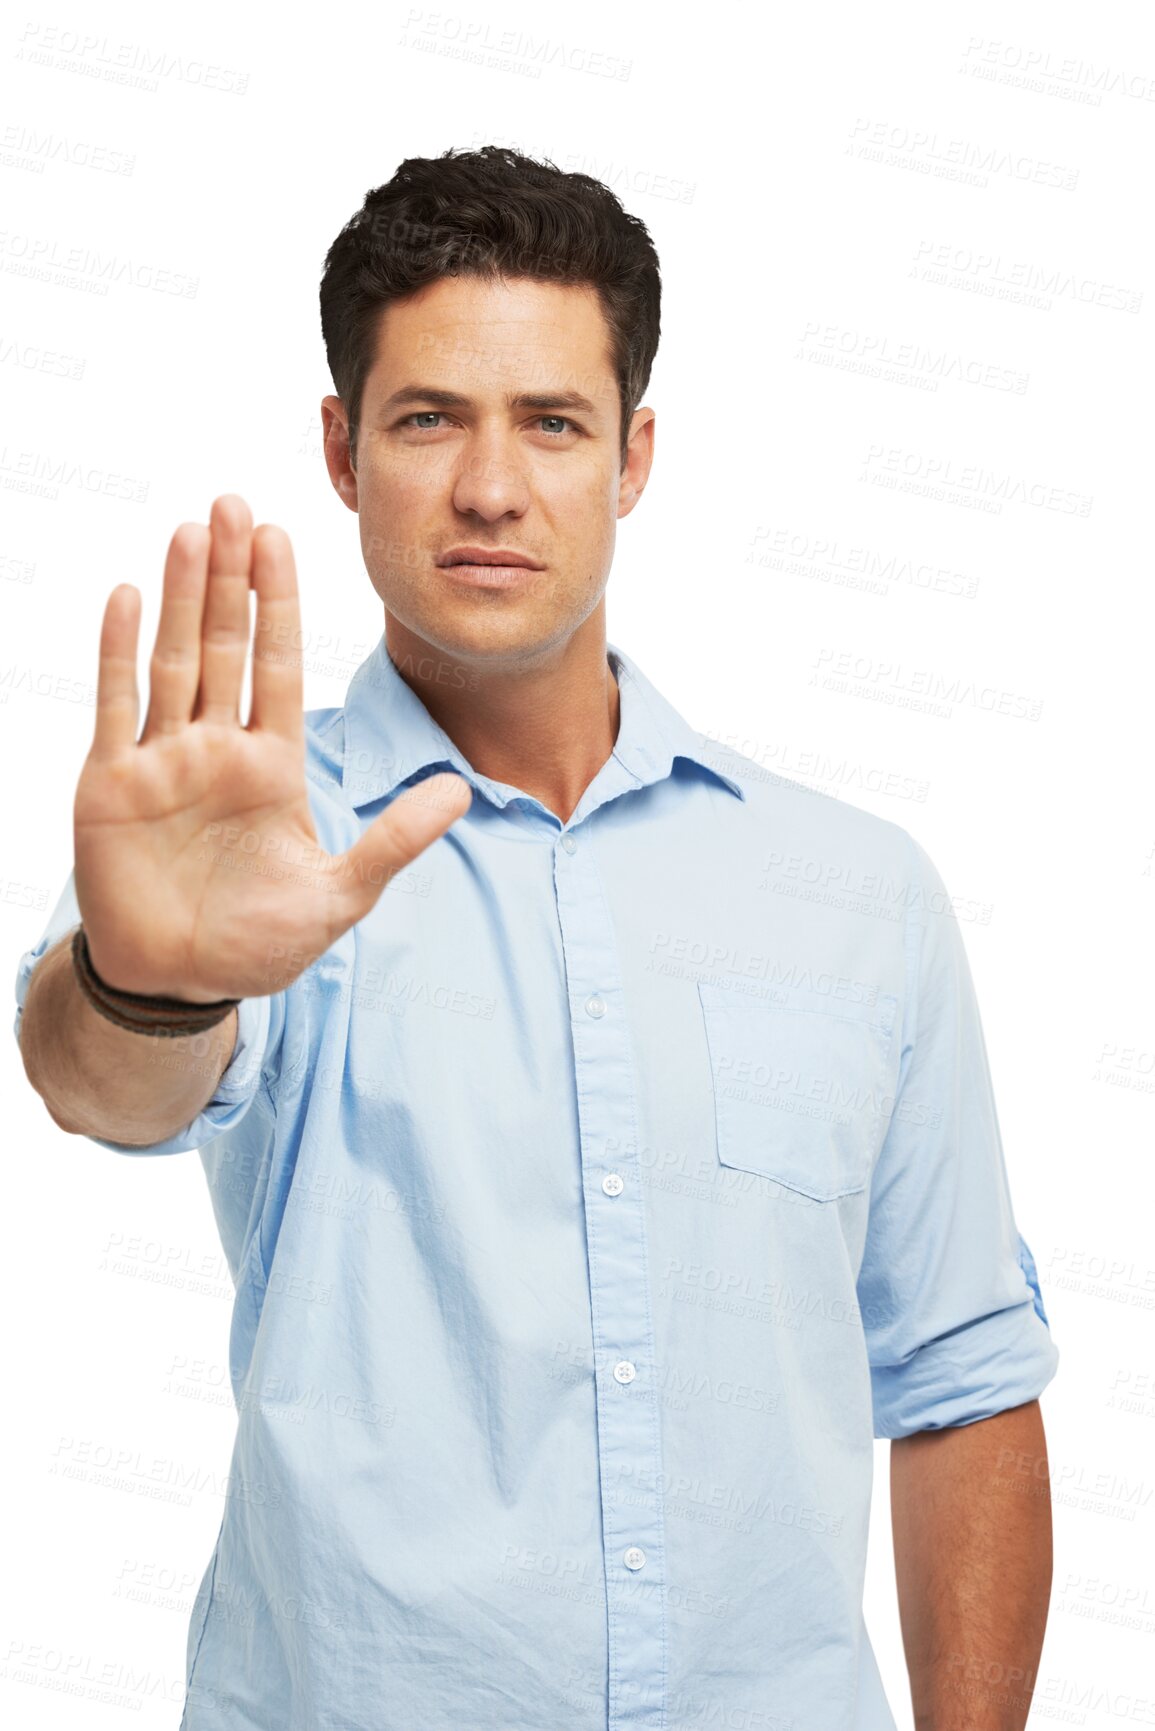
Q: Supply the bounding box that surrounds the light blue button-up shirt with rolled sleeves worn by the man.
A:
[17,637,1058,1731]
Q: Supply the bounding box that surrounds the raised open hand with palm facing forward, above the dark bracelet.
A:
[73,493,471,1004]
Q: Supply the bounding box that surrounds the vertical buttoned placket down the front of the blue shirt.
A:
[554,824,667,1731]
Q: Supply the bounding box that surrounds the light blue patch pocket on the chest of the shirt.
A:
[698,980,897,1201]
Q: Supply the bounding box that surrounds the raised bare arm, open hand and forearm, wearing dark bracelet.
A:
[17,495,471,1151]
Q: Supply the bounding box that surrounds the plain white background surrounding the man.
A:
[0,0,1155,1731]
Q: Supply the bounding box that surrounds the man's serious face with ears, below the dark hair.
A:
[322,277,653,666]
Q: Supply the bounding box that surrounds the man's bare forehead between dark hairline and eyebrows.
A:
[365,277,616,403]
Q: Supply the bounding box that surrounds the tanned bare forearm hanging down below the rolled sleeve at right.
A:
[890,1400,1051,1731]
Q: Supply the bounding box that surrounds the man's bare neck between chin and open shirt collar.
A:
[384,606,622,824]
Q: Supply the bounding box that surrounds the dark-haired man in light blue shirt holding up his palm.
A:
[17,147,1056,1731]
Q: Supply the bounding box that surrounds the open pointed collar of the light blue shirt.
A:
[341,632,746,807]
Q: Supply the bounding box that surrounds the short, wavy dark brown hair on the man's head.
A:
[320,144,661,466]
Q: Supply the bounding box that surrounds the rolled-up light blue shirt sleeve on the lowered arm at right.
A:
[857,836,1058,1437]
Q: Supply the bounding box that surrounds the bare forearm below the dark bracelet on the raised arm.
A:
[21,931,237,1148]
